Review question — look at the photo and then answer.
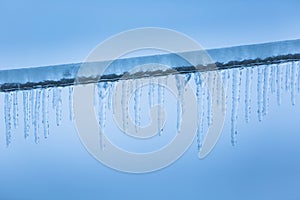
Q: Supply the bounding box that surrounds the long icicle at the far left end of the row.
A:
[4,92,12,146]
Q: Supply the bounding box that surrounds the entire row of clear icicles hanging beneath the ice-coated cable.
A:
[4,62,300,150]
